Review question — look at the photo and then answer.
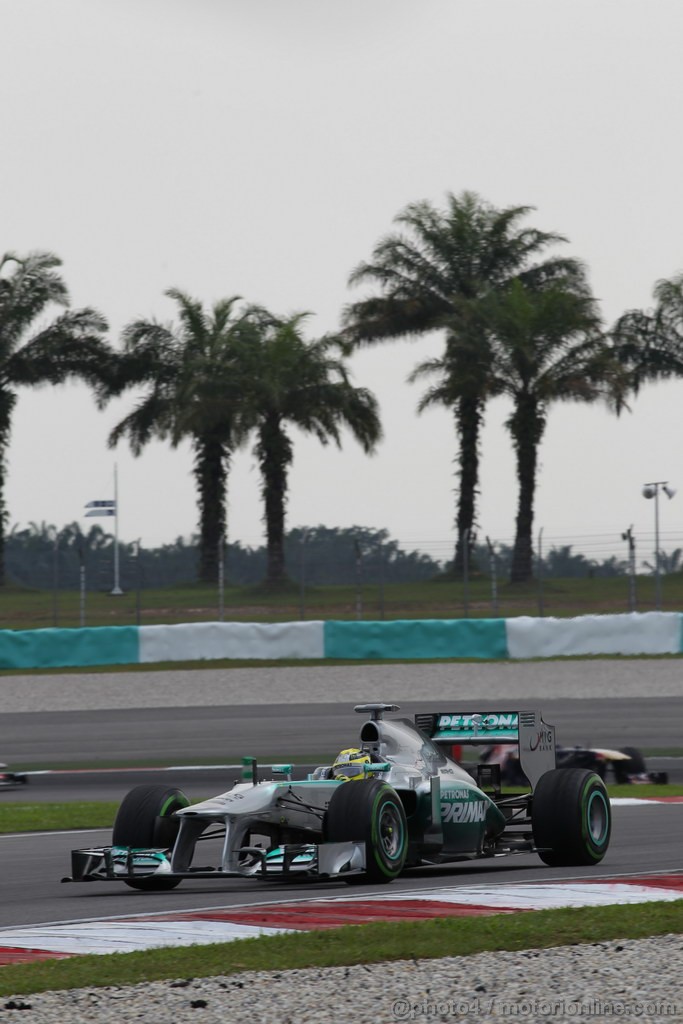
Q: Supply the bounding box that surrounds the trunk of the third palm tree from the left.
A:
[257,414,292,587]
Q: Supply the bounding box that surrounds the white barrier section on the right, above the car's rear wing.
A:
[506,611,681,658]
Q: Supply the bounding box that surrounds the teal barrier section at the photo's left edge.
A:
[0,626,139,669]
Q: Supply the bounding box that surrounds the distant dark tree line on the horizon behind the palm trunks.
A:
[6,522,683,591]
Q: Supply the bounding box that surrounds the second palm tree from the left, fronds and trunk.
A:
[105,289,253,583]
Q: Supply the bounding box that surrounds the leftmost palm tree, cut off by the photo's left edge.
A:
[0,252,107,586]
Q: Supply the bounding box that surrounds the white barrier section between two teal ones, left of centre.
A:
[139,622,325,664]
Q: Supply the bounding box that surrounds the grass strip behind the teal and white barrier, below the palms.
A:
[0,572,683,630]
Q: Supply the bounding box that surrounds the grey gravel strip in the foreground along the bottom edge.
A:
[0,935,683,1024]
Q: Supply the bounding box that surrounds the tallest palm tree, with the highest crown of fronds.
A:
[344,191,580,572]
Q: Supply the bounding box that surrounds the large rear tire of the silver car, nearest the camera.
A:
[531,768,611,867]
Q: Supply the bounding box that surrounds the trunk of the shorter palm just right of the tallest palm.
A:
[510,395,545,583]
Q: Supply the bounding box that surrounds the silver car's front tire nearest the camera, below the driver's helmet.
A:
[325,778,408,883]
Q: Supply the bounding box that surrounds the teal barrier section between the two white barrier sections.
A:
[325,618,508,658]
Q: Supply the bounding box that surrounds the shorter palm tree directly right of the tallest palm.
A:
[473,274,620,583]
